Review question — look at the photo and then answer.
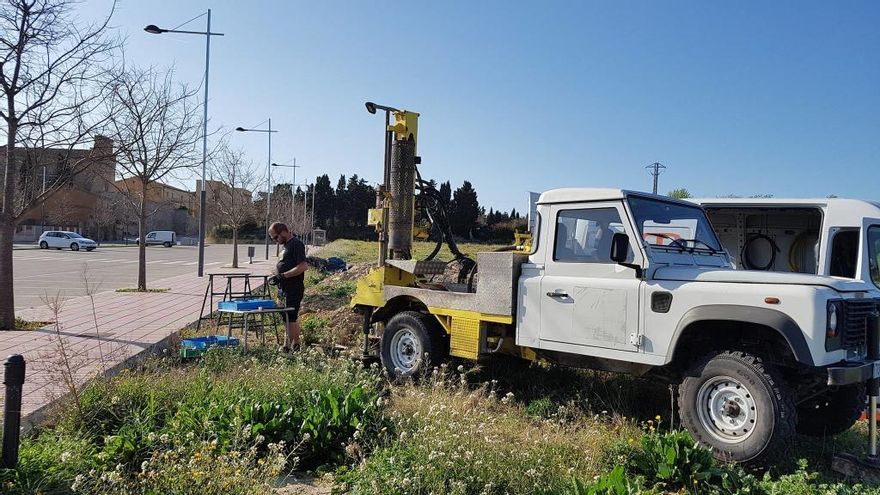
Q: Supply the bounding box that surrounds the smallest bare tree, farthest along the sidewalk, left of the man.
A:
[206,148,262,268]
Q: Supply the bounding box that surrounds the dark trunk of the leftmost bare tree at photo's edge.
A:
[0,118,18,330]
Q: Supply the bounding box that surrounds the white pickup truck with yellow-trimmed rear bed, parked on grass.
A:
[352,188,880,461]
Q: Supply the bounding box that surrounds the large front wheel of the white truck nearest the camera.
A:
[678,351,797,464]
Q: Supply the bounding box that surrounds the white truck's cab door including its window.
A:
[540,202,642,352]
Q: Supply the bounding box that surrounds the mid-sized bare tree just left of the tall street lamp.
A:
[109,68,201,291]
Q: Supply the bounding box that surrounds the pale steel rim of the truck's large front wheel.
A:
[697,376,758,444]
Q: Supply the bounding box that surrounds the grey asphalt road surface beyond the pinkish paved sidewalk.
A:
[12,245,275,309]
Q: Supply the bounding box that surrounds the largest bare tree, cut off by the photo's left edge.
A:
[0,0,117,328]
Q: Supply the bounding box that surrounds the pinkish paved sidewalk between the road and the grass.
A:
[0,262,272,425]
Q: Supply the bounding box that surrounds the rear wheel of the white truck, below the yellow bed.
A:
[381,311,449,378]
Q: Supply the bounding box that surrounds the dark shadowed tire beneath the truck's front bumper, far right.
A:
[797,383,867,437]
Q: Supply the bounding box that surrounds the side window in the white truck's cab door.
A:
[553,208,621,263]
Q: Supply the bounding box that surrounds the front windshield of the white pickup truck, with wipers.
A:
[628,196,721,253]
